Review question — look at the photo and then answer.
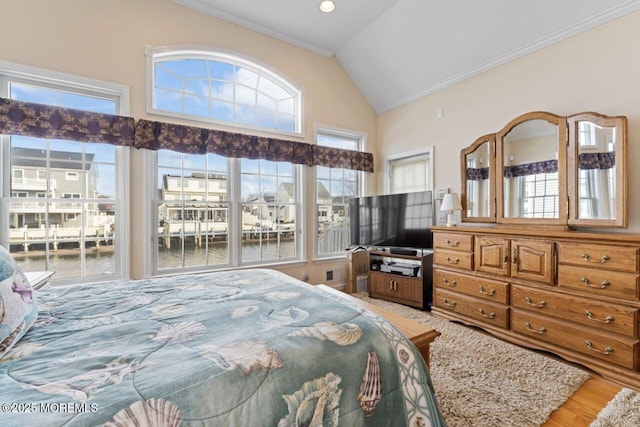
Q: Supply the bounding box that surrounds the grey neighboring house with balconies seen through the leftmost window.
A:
[9,147,103,229]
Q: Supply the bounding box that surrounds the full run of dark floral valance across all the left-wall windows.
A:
[0,98,373,172]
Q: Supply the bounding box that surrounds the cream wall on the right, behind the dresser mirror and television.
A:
[375,8,640,232]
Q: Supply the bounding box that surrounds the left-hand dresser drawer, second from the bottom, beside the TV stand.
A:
[433,269,509,304]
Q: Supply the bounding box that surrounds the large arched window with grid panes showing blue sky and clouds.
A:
[146,47,302,134]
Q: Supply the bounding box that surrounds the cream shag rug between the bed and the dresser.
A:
[352,292,589,427]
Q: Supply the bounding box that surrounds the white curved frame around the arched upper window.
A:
[145,45,304,137]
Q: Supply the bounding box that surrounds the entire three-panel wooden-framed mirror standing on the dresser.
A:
[461,111,627,227]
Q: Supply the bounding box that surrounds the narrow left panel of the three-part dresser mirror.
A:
[460,134,496,222]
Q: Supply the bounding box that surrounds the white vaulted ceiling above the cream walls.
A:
[172,0,640,113]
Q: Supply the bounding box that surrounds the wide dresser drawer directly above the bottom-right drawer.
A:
[511,285,640,337]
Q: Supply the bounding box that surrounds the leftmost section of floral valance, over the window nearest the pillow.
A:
[0,98,135,146]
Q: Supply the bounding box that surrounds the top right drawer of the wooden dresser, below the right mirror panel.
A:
[558,242,640,273]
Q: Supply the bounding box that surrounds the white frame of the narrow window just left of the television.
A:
[314,125,367,261]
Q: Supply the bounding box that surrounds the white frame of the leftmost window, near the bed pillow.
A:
[0,60,130,285]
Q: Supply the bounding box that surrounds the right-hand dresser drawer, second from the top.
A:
[558,265,640,301]
